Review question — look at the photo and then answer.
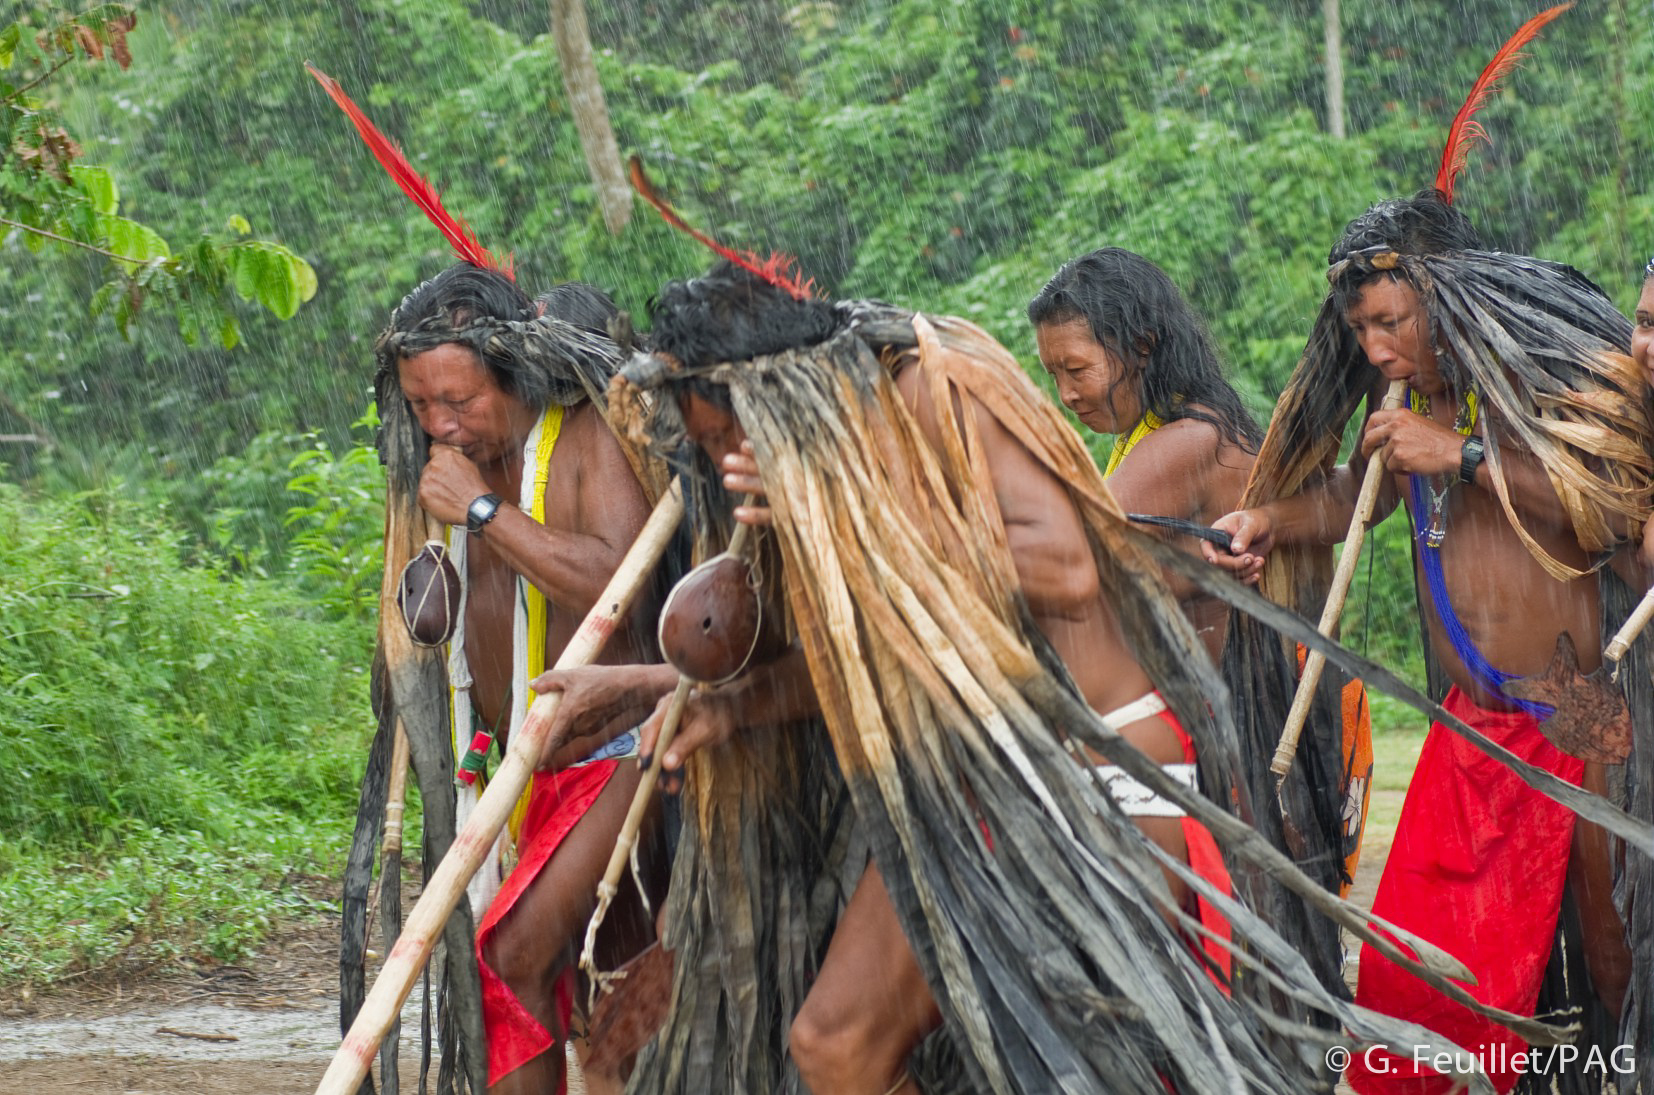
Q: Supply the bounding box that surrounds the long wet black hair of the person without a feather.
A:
[1029,246,1264,453]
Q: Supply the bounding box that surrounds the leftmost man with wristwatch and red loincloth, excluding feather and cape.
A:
[380,265,653,1093]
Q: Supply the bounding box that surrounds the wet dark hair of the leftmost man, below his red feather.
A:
[375,263,549,407]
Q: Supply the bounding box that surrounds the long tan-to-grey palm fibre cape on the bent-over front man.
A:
[614,306,1587,1095]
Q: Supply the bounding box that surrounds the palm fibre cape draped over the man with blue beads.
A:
[1226,248,1654,1092]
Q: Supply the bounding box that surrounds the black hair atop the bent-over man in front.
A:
[648,260,842,410]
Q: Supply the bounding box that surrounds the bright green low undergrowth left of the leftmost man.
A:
[0,482,377,983]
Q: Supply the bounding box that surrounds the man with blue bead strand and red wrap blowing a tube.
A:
[1206,190,1647,1092]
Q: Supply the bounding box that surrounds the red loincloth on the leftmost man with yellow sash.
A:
[476,761,620,1095]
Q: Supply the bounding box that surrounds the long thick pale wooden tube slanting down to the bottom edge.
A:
[316,483,683,1095]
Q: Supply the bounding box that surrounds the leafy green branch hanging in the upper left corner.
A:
[0,3,316,349]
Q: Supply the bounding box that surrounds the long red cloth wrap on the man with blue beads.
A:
[1346,688,1585,1095]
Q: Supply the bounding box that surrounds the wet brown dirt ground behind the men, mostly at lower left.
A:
[0,791,1401,1095]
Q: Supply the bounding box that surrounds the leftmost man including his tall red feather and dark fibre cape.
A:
[306,66,675,1095]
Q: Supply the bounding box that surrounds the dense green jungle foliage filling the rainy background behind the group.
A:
[0,0,1654,976]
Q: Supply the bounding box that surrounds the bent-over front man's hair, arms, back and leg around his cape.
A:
[562,263,1227,1095]
